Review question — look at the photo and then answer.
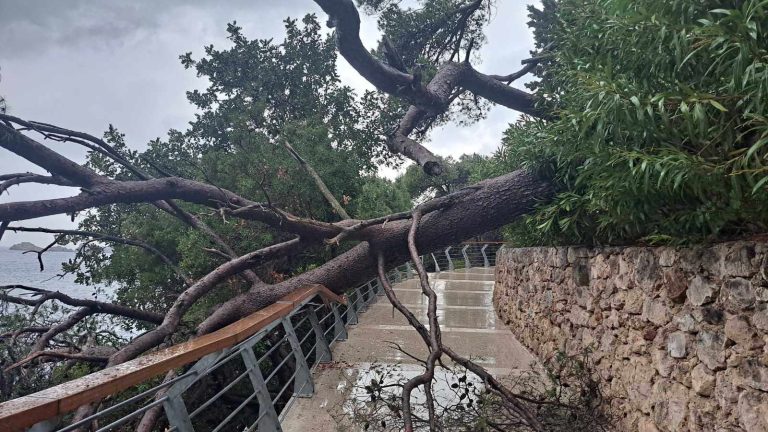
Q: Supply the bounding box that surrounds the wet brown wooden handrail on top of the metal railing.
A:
[0,285,346,432]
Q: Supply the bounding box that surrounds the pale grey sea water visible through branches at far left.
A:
[0,248,109,300]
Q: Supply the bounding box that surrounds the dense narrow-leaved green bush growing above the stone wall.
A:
[497,0,768,244]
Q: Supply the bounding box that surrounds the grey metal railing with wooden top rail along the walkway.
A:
[0,243,501,432]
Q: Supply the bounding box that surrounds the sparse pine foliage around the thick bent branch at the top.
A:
[357,0,494,152]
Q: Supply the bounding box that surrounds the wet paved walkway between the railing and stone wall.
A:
[282,268,534,432]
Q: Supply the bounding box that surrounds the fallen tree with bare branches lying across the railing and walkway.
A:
[0,0,554,429]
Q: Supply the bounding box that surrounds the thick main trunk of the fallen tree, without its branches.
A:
[198,170,553,334]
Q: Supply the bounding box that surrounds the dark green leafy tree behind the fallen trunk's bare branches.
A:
[68,15,410,325]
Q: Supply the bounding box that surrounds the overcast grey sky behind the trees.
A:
[0,0,533,246]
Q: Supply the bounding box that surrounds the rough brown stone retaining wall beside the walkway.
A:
[493,242,768,432]
